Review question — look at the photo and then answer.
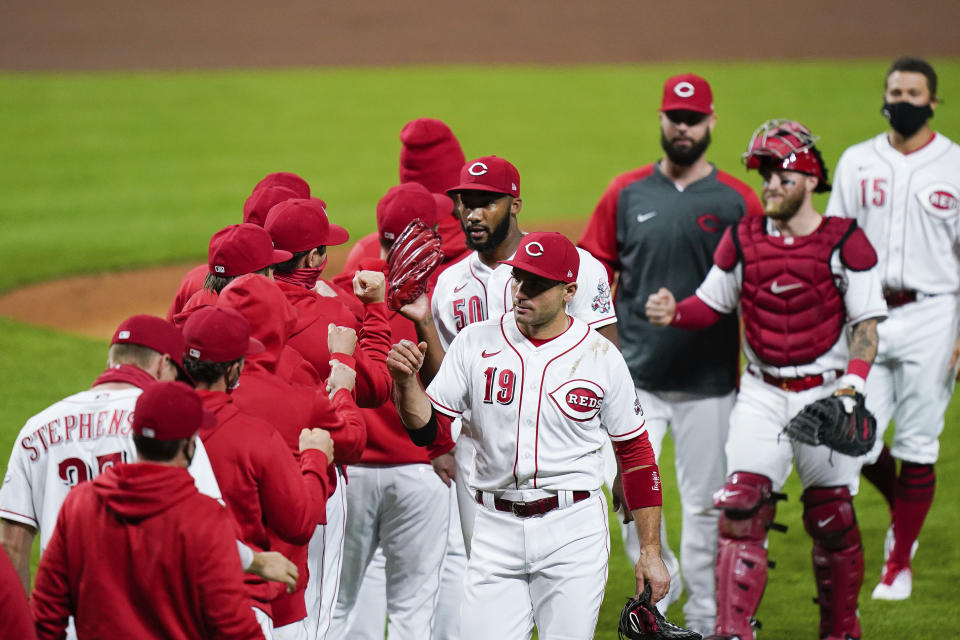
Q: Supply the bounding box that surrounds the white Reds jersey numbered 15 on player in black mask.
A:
[827,133,960,294]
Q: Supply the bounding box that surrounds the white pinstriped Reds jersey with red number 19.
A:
[427,312,645,491]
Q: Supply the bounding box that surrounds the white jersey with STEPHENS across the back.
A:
[0,387,222,553]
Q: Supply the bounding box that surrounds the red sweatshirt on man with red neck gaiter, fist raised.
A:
[276,280,393,407]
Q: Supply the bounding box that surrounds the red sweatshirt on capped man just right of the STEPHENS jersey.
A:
[197,390,329,615]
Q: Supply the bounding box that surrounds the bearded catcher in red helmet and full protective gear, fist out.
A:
[646,120,886,640]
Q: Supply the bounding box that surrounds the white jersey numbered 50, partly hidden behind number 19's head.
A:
[431,248,617,349]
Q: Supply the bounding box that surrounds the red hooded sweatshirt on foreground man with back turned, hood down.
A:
[31,463,263,640]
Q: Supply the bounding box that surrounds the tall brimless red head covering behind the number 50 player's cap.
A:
[400,118,467,193]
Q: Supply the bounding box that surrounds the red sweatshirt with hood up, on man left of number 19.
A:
[218,274,367,626]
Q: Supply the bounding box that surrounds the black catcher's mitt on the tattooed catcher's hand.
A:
[784,389,877,456]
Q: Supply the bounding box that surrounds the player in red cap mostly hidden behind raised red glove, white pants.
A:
[326,182,452,639]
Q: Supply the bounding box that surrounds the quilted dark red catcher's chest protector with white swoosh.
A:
[734,216,852,367]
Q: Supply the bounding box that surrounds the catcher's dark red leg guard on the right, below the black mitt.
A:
[802,487,863,640]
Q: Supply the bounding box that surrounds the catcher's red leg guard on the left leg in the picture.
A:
[713,471,785,640]
